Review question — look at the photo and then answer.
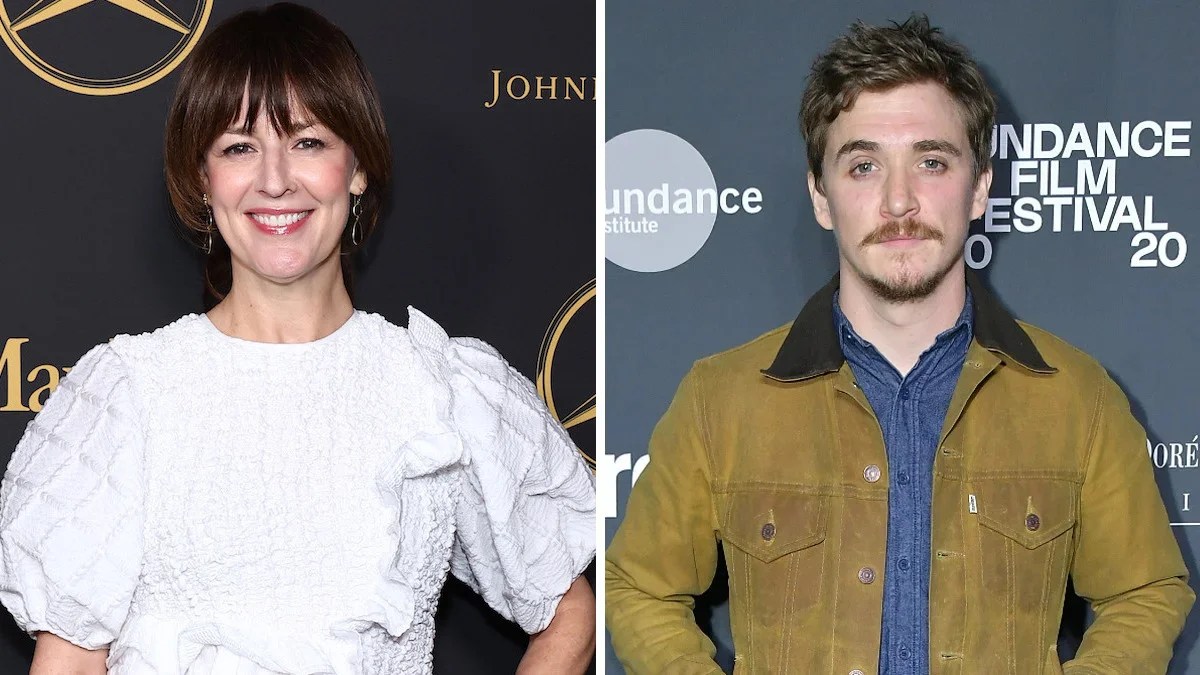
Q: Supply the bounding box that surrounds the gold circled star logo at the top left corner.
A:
[0,0,212,96]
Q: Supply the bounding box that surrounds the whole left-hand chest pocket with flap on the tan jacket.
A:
[721,490,829,622]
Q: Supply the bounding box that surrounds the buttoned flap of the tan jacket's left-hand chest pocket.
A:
[721,491,829,562]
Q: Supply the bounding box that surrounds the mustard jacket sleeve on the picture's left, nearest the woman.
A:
[605,369,721,675]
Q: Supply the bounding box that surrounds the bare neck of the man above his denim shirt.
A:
[838,265,967,376]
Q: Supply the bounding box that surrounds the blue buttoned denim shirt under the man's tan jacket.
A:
[833,289,973,675]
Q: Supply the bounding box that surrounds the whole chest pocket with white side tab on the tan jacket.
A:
[968,478,1078,619]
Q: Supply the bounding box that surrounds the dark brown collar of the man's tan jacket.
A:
[762,270,1056,382]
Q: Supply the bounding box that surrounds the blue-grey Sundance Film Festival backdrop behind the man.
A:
[609,0,1200,674]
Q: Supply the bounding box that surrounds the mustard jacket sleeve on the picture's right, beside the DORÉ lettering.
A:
[1063,377,1195,675]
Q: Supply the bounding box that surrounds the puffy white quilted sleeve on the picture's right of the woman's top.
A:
[449,339,595,633]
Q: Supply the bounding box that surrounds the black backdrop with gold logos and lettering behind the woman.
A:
[0,0,596,673]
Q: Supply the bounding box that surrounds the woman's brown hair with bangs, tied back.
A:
[164,2,391,307]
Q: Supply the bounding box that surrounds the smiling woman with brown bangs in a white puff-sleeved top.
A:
[0,5,594,675]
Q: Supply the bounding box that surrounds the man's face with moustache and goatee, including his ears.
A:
[809,83,991,303]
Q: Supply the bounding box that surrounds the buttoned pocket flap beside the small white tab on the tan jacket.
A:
[973,478,1075,549]
